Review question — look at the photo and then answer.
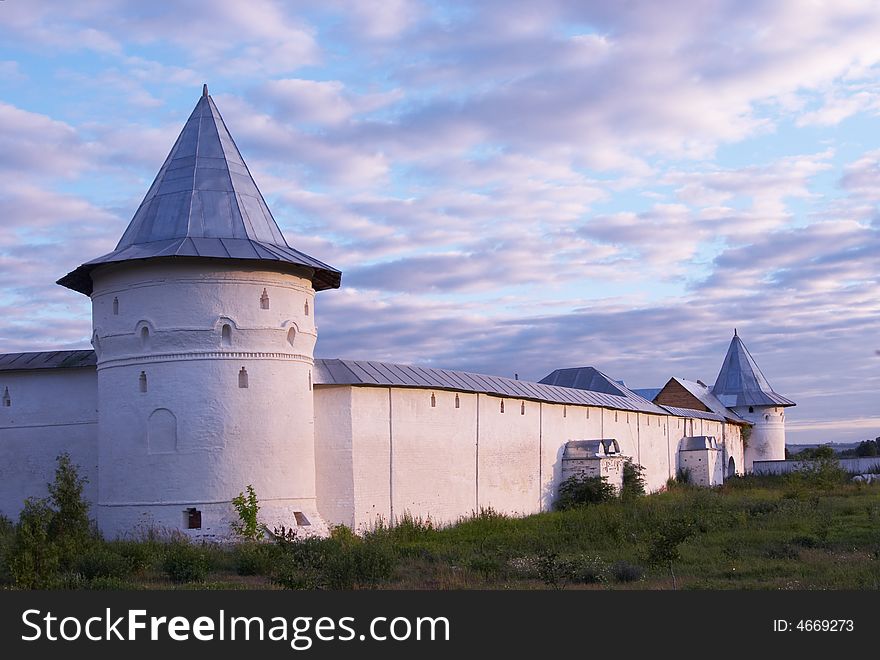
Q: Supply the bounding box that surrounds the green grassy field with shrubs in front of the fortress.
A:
[0,466,880,589]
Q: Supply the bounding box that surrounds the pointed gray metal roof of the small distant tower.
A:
[712,331,796,408]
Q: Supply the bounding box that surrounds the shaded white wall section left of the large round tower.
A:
[0,367,98,520]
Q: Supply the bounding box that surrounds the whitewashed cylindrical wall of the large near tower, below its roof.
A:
[92,261,323,537]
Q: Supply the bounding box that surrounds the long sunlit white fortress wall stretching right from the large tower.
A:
[324,386,722,529]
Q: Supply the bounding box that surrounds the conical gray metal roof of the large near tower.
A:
[58,86,342,295]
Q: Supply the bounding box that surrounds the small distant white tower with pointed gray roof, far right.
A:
[712,330,795,472]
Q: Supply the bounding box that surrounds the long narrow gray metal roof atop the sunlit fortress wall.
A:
[315,360,668,415]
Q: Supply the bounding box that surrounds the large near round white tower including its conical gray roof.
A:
[58,87,341,537]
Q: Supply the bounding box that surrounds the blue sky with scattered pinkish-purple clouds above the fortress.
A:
[0,0,880,443]
